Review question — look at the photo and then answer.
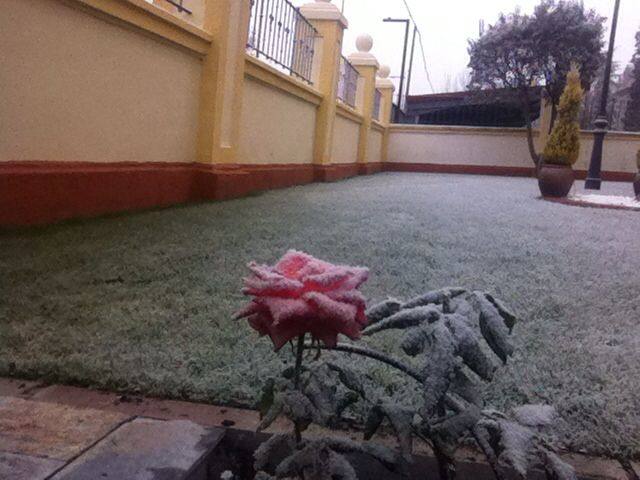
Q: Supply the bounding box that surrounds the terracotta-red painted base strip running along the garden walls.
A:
[0,162,633,226]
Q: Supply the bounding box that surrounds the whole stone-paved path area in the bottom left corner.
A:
[0,382,224,480]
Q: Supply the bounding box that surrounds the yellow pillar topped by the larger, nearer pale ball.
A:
[349,34,380,165]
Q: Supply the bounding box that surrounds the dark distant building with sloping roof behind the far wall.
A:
[400,87,542,127]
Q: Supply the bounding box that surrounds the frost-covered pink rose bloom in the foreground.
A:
[236,250,369,350]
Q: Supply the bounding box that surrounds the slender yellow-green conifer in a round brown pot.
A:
[538,65,583,197]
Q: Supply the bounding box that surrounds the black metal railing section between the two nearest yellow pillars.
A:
[247,0,318,83]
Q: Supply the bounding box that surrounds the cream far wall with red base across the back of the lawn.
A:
[386,125,640,181]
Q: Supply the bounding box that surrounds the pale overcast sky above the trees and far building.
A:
[293,0,640,94]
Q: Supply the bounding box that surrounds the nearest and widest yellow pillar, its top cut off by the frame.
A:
[198,0,251,165]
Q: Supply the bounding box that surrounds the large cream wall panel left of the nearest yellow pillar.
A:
[0,0,201,162]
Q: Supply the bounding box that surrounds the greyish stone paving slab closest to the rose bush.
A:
[52,418,224,480]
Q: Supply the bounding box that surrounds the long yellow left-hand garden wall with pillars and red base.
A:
[0,0,391,226]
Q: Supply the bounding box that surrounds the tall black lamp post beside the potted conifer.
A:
[584,0,620,190]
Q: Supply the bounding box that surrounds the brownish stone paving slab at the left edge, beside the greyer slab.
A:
[0,397,129,461]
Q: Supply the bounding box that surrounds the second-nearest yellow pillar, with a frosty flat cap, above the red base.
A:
[300,0,348,166]
